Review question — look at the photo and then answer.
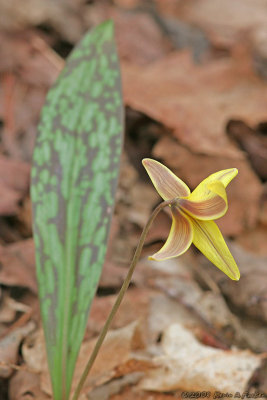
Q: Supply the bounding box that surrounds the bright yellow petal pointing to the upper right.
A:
[190,168,238,201]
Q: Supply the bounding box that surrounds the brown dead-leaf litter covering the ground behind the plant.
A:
[0,0,267,400]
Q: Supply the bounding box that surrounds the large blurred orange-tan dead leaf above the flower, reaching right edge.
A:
[122,52,267,159]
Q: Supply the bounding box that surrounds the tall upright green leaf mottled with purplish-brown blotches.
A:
[31,21,123,400]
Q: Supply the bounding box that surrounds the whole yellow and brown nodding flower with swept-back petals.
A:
[142,158,240,280]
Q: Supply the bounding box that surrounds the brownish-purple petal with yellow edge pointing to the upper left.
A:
[142,158,190,200]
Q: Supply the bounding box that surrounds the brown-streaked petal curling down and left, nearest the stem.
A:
[149,207,193,261]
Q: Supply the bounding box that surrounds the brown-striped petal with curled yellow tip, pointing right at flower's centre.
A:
[178,181,228,220]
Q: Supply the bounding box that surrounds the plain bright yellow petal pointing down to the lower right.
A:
[192,219,240,281]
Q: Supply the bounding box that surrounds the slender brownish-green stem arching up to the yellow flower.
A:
[72,199,175,400]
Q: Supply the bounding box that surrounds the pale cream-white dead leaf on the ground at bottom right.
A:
[140,324,262,393]
